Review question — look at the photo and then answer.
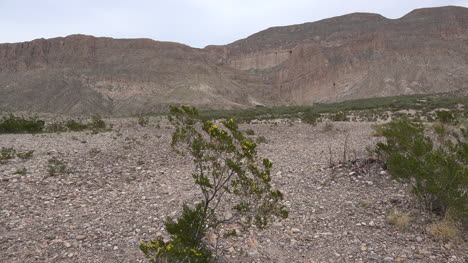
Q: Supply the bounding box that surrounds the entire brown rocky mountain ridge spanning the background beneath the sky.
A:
[0,7,468,114]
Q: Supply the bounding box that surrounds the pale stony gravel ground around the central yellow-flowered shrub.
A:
[0,119,467,263]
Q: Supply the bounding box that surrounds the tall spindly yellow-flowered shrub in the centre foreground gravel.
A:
[140,105,288,262]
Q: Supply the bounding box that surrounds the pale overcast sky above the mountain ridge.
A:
[0,0,468,48]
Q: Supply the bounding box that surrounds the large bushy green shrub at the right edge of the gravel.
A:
[375,119,468,221]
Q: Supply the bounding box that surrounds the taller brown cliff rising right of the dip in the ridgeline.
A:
[222,7,468,104]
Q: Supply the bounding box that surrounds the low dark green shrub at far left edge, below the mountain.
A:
[0,114,45,133]
